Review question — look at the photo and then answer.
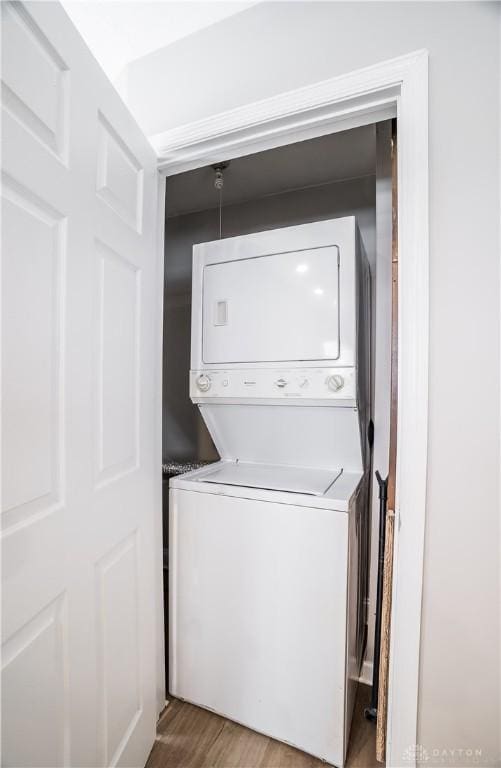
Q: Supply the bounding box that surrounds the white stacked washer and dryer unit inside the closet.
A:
[169,217,370,766]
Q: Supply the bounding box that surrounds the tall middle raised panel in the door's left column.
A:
[2,176,66,530]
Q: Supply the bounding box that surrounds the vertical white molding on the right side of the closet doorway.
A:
[387,48,429,766]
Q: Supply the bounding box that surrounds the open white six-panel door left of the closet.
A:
[1,2,161,768]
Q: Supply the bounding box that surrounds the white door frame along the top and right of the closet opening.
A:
[154,50,429,768]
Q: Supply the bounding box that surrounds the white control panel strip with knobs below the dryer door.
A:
[190,368,356,401]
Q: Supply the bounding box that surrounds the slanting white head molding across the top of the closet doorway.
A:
[153,51,425,175]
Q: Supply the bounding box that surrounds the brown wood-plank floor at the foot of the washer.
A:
[146,685,380,768]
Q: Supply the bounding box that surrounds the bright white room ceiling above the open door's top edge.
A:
[62,0,256,85]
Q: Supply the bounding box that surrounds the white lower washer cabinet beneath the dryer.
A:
[169,462,362,765]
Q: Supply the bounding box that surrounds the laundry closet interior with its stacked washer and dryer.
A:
[163,121,392,766]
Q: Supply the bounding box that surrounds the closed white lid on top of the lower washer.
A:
[201,462,343,496]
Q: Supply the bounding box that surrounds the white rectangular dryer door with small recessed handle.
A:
[203,245,340,365]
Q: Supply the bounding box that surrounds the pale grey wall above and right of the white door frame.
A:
[129,2,501,766]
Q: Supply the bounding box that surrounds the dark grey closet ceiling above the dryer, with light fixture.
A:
[167,125,376,217]
